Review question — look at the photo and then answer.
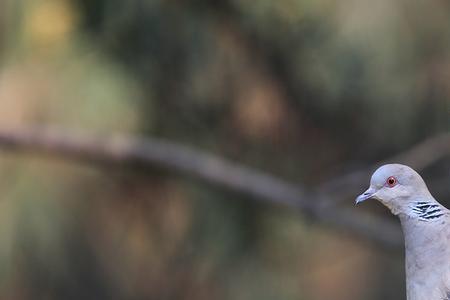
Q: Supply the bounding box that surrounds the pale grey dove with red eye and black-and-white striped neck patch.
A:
[356,164,450,300]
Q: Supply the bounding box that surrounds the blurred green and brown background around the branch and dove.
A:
[0,0,450,300]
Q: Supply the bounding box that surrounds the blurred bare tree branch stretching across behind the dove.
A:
[0,128,430,249]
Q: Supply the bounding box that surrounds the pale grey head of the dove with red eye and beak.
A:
[356,164,433,215]
